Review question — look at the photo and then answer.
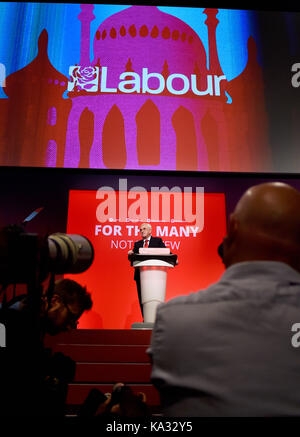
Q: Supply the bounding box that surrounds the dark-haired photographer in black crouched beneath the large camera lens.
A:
[0,279,92,416]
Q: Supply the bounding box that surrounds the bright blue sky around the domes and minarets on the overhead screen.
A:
[0,3,255,80]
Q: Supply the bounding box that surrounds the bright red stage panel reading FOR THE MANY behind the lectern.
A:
[67,186,226,329]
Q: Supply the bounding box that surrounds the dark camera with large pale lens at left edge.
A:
[0,225,94,285]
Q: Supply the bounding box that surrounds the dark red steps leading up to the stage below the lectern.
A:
[45,329,159,412]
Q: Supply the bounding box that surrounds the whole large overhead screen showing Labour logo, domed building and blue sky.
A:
[0,2,300,172]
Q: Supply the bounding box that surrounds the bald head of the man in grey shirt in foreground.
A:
[224,182,300,270]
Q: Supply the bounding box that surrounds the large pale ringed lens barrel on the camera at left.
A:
[48,233,94,274]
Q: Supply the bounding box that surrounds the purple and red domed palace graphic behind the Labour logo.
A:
[0,4,271,171]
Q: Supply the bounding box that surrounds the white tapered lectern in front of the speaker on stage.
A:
[128,247,177,329]
